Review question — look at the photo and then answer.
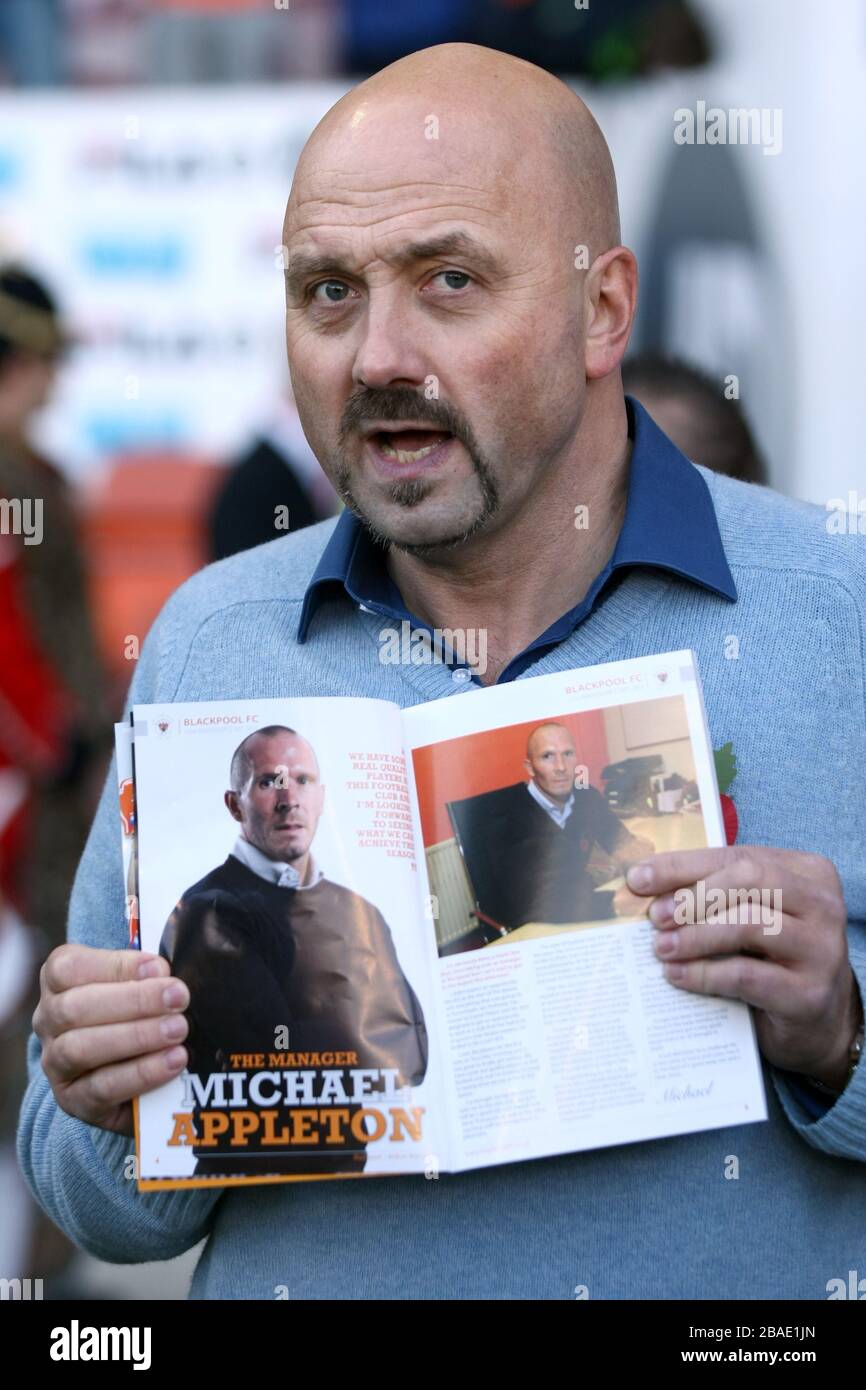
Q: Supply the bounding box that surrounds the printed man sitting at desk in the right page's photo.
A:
[448,721,655,951]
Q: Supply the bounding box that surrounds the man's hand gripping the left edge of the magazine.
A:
[33,945,189,1134]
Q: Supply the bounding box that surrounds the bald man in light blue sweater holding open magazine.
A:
[19,44,866,1300]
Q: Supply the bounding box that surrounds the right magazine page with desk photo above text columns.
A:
[403,652,766,1168]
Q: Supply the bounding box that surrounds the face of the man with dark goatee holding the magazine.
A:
[284,99,585,553]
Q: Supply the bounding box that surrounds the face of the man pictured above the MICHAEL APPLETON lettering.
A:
[225,734,325,863]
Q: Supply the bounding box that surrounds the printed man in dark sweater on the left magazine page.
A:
[160,724,427,1177]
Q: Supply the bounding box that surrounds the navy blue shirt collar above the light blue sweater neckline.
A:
[297,396,737,667]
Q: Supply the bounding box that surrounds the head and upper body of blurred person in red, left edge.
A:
[0,265,111,954]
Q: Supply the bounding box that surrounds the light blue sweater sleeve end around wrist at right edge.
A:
[770,922,866,1163]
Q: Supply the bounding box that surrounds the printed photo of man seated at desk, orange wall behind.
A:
[413,695,709,956]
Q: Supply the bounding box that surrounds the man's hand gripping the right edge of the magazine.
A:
[627,845,862,1091]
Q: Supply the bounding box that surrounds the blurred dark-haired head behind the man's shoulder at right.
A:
[623,353,770,487]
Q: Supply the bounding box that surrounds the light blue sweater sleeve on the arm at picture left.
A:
[18,592,221,1264]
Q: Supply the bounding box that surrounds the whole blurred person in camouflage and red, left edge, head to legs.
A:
[0,267,101,1297]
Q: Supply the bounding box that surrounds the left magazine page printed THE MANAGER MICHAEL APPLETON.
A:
[133,698,442,1188]
